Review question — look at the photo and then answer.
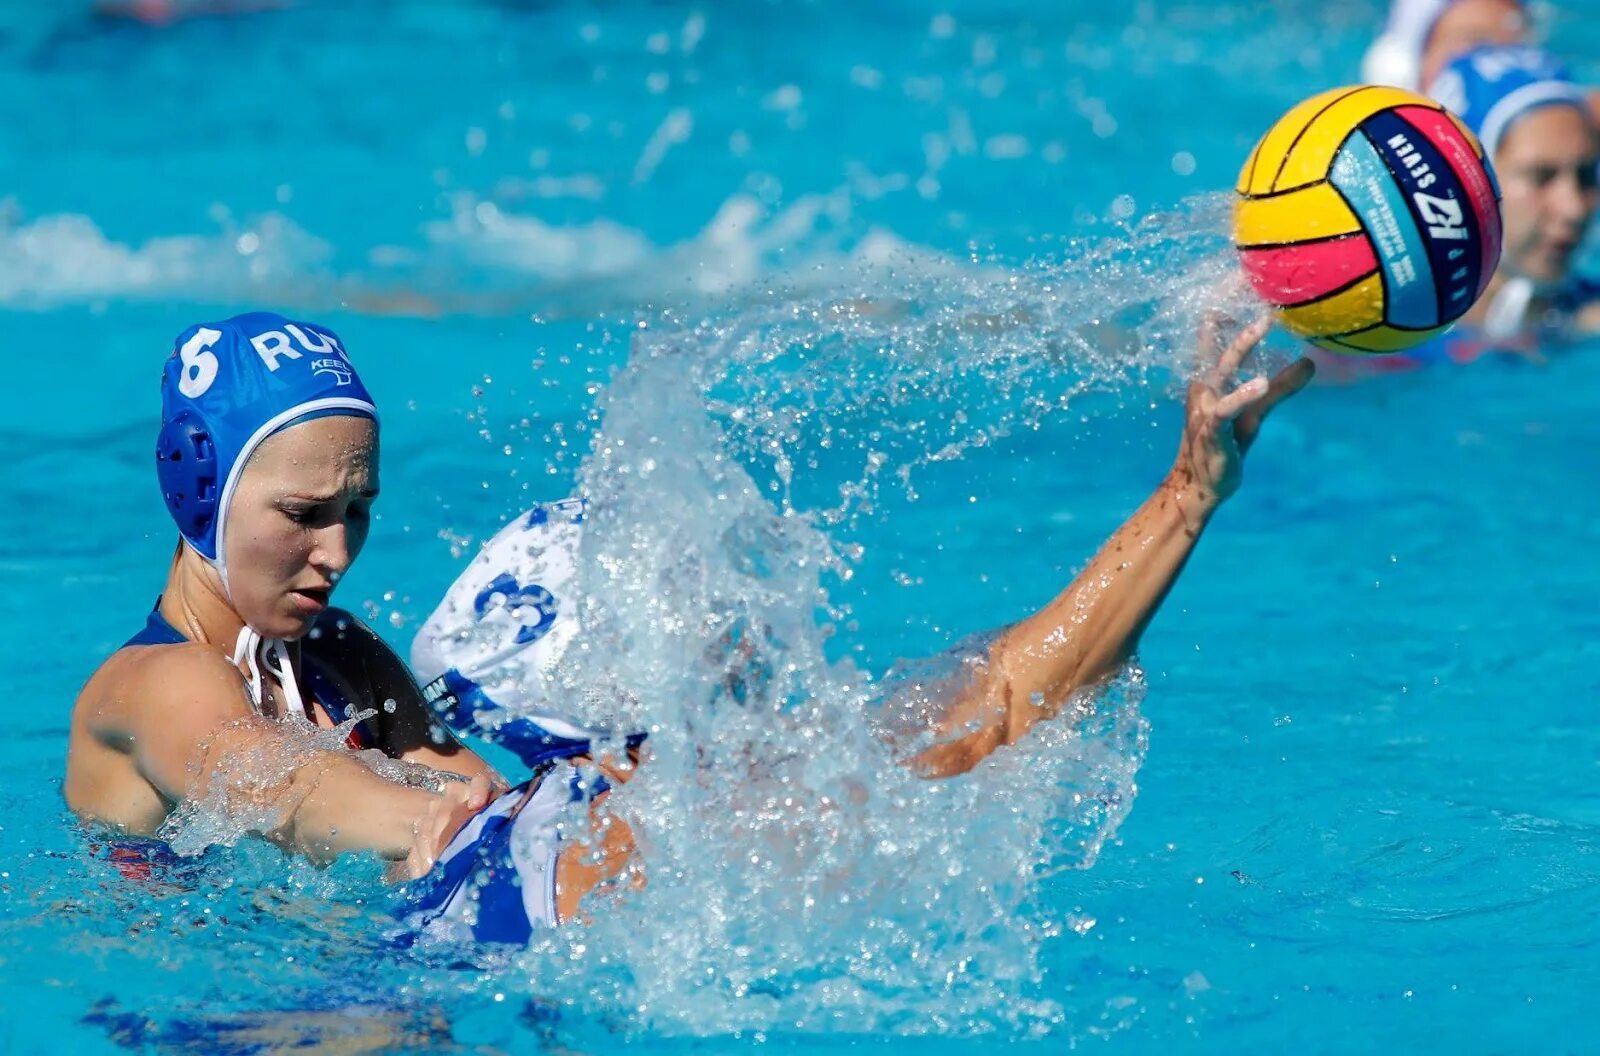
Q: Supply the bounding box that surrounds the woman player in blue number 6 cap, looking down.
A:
[66,314,505,867]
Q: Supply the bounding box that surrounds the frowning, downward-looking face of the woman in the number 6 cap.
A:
[226,416,378,638]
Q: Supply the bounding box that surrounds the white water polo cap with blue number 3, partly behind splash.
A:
[411,499,642,766]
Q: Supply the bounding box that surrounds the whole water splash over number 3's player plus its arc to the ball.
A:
[457,200,1235,1035]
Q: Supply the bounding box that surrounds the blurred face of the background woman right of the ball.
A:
[1494,106,1600,283]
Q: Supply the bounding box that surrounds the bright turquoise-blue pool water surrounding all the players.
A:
[0,0,1600,1053]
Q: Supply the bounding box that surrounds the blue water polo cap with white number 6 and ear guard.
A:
[155,312,378,569]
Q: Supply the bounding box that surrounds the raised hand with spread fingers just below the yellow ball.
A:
[1173,314,1317,515]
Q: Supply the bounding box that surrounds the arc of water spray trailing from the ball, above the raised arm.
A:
[630,195,1259,525]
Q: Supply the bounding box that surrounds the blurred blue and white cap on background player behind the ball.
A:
[1429,46,1587,160]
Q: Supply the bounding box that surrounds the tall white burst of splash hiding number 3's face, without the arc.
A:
[533,354,1144,1032]
